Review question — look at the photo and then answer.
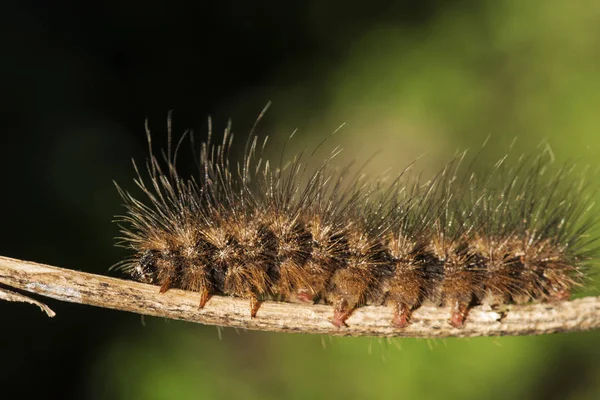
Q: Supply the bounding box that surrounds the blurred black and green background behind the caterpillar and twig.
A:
[0,0,600,399]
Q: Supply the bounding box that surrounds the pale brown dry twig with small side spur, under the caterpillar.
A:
[0,256,600,338]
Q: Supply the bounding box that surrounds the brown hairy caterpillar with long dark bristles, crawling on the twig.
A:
[111,111,595,328]
